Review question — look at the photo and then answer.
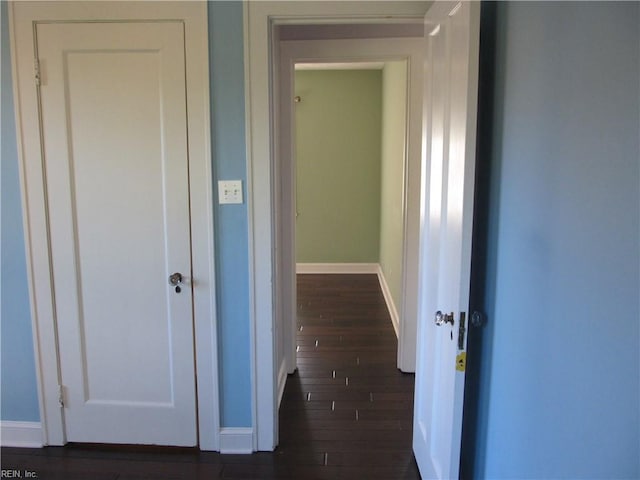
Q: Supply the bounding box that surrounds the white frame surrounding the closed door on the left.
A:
[9,1,220,450]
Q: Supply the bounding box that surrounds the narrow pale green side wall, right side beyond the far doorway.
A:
[380,61,407,308]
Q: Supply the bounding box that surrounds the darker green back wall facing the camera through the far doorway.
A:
[295,70,382,263]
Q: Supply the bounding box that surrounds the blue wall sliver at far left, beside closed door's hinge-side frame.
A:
[0,2,40,421]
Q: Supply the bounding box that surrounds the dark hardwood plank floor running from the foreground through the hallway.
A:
[1,275,420,480]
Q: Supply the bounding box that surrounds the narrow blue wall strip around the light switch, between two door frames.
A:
[209,1,252,427]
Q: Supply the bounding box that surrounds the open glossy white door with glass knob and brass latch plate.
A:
[413,2,480,479]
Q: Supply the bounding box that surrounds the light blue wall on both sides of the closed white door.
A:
[0,2,252,427]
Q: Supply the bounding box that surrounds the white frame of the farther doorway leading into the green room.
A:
[274,37,424,378]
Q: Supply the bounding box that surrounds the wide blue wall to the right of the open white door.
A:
[476,2,640,479]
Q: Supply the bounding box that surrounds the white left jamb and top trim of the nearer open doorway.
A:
[244,1,431,451]
